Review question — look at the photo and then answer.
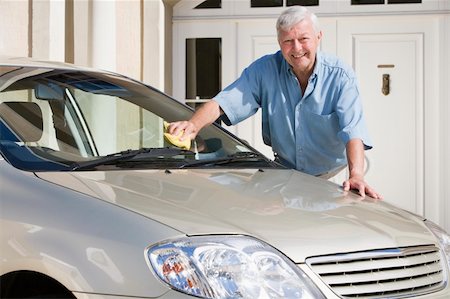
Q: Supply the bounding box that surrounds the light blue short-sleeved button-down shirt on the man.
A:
[214,51,372,175]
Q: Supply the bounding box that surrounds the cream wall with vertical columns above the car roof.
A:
[0,0,170,89]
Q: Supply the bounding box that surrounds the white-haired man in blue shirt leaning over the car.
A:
[169,6,381,199]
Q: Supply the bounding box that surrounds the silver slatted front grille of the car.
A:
[306,245,445,298]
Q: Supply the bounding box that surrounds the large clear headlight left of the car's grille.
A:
[146,236,324,299]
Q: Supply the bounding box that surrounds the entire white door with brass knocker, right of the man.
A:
[337,17,440,222]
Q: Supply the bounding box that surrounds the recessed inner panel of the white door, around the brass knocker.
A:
[353,34,424,214]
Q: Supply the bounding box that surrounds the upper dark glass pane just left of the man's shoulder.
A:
[186,38,222,99]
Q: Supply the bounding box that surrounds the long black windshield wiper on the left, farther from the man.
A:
[70,147,195,170]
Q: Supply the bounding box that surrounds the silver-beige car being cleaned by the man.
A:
[0,58,450,299]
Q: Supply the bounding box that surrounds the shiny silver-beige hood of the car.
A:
[38,169,434,262]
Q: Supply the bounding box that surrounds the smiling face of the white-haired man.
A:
[278,19,322,73]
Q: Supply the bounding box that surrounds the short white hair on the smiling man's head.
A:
[277,6,320,35]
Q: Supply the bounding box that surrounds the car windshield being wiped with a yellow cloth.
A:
[0,67,275,171]
